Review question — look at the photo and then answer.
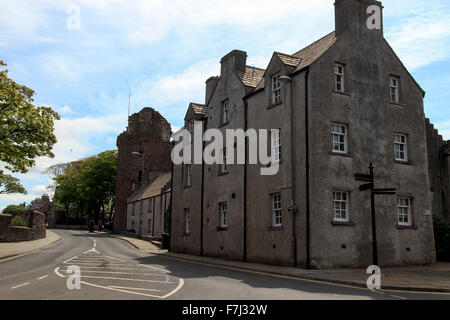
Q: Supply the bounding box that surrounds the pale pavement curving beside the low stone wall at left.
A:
[0,230,61,260]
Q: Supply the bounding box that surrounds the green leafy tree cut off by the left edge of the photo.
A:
[0,61,59,173]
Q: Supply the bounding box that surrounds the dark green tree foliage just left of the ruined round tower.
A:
[50,150,117,218]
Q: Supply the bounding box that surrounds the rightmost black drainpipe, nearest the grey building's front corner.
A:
[305,67,311,269]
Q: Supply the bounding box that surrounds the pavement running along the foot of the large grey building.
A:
[113,235,450,293]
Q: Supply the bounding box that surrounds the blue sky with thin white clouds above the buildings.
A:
[0,0,450,210]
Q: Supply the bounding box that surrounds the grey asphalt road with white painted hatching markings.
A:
[0,230,450,300]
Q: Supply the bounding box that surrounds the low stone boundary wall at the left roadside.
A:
[0,210,47,242]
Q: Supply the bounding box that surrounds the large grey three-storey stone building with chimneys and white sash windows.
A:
[171,0,449,268]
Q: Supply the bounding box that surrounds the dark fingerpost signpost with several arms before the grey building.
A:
[355,162,396,265]
